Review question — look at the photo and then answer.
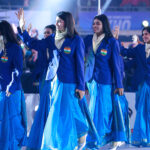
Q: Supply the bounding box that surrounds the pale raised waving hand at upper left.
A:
[16,8,25,32]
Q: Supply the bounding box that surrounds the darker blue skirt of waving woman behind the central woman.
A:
[28,76,51,149]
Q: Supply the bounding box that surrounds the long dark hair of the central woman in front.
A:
[57,11,78,38]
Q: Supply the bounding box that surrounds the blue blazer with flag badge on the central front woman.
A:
[57,35,85,90]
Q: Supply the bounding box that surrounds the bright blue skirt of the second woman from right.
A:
[87,80,113,147]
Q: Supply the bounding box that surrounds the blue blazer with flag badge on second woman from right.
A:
[84,35,123,88]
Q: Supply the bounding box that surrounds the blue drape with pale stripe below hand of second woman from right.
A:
[112,94,130,143]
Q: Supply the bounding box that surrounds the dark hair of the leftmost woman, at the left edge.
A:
[0,20,19,44]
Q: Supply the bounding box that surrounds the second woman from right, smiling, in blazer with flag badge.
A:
[84,15,123,147]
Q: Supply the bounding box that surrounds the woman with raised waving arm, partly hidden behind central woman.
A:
[17,9,55,149]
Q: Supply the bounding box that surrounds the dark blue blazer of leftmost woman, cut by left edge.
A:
[0,42,23,93]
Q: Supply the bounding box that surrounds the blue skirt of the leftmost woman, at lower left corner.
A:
[0,90,27,150]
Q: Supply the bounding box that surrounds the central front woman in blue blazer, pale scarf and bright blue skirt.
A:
[42,11,88,150]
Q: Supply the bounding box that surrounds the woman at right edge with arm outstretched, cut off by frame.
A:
[121,26,150,146]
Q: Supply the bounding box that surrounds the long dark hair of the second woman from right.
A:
[93,14,113,38]
